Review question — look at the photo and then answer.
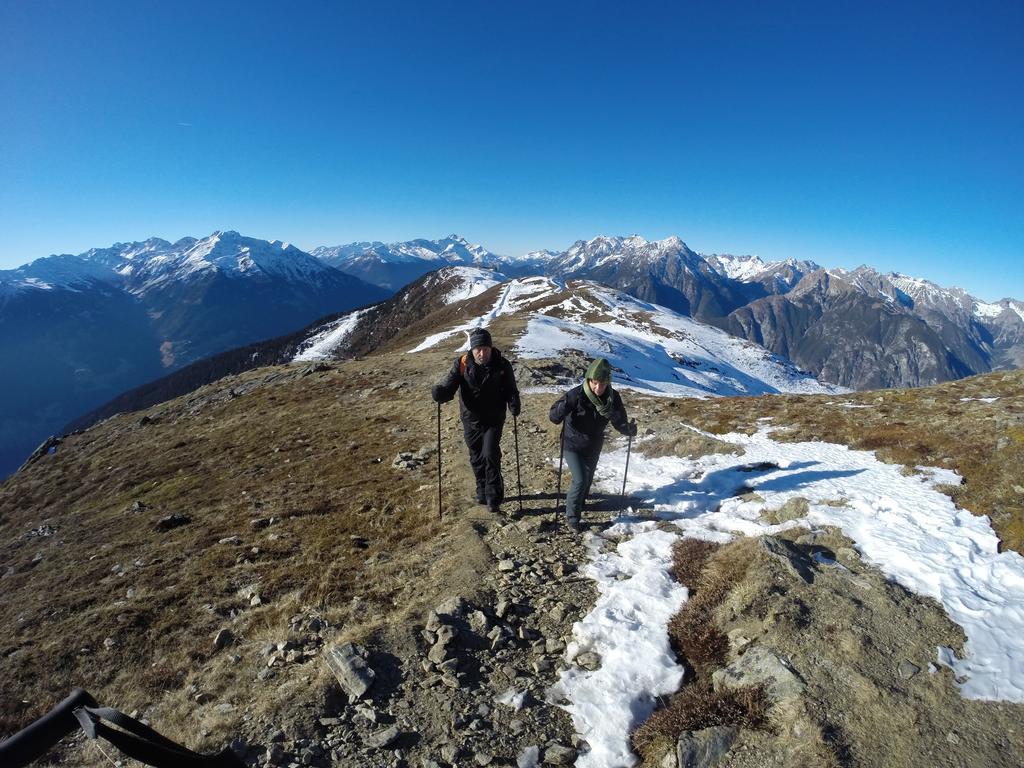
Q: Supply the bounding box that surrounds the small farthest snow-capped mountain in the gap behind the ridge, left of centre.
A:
[312,234,500,292]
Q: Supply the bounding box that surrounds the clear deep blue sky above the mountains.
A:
[0,0,1024,300]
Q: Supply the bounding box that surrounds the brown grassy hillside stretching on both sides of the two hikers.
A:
[0,333,1024,765]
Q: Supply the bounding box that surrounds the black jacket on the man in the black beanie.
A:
[437,347,520,426]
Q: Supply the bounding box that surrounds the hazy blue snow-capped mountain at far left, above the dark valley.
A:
[0,231,387,476]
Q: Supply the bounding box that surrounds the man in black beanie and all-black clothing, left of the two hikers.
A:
[431,328,520,512]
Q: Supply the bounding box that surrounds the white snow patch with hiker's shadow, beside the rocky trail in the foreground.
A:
[551,428,1024,766]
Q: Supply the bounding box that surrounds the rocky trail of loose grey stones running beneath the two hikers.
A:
[303,403,638,768]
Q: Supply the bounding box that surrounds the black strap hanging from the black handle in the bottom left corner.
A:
[75,707,245,768]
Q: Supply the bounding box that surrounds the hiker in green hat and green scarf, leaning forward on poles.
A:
[548,357,637,532]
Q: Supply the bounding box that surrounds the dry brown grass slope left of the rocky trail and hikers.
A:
[0,362,447,740]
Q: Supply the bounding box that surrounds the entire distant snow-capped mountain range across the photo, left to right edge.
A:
[0,231,1024,476]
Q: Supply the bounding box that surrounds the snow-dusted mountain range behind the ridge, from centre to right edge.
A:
[317,236,1024,389]
